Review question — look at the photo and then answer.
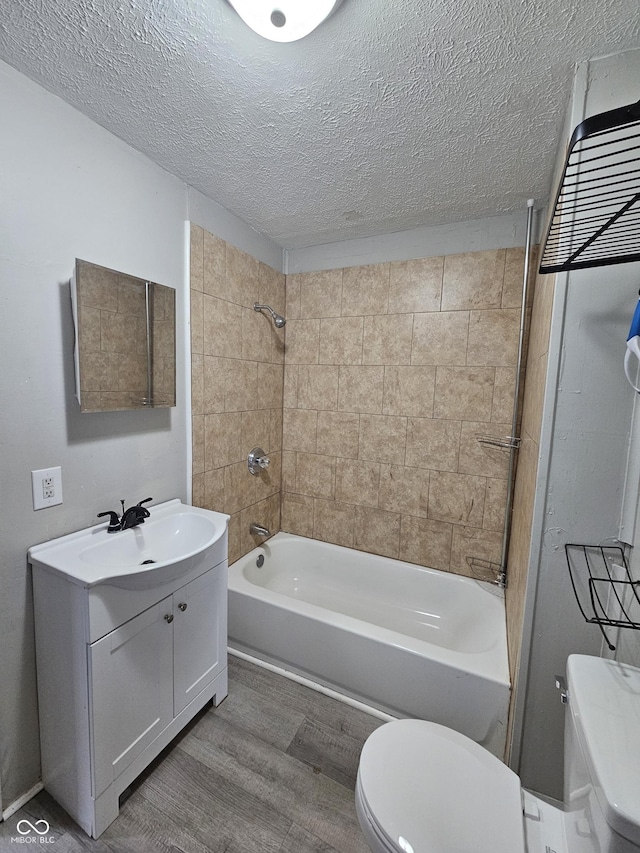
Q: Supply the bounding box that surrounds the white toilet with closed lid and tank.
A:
[356,655,640,853]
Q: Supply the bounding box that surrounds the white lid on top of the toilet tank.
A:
[567,655,640,845]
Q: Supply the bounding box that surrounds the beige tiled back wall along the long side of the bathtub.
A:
[282,249,524,574]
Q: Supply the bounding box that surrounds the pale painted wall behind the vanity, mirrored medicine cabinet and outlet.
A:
[0,63,281,809]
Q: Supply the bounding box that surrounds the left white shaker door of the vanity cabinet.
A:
[89,596,173,797]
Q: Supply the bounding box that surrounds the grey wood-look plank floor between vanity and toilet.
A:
[0,657,381,853]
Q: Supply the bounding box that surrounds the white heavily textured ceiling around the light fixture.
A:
[0,0,640,248]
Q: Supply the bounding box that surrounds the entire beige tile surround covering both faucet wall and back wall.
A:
[191,220,524,574]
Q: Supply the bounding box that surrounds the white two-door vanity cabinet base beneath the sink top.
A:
[29,500,227,838]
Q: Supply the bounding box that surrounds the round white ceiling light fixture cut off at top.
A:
[229,0,341,41]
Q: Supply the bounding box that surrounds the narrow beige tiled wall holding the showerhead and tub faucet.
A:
[191,225,285,563]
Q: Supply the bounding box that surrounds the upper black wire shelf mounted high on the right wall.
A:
[540,101,640,273]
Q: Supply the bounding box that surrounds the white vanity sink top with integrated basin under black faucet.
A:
[29,499,229,589]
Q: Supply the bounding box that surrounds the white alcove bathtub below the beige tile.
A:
[229,533,510,758]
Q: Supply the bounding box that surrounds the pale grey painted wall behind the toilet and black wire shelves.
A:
[519,51,640,799]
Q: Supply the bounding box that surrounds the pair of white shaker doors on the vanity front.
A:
[89,568,226,795]
